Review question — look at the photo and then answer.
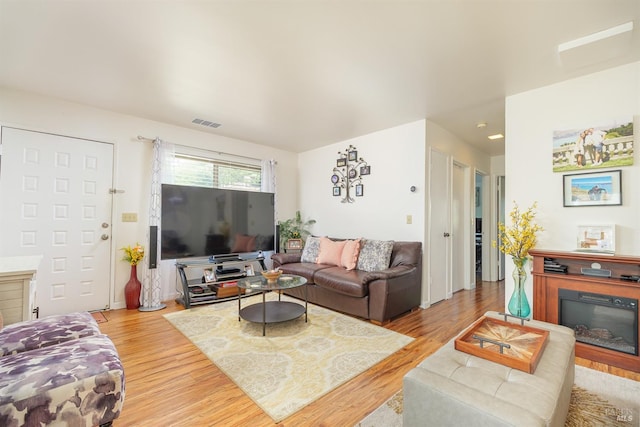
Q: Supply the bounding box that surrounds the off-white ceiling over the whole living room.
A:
[0,0,640,155]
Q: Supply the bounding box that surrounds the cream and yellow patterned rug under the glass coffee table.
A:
[164,293,413,422]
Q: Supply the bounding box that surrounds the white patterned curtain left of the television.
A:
[140,138,175,311]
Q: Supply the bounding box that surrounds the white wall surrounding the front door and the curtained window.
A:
[0,88,298,308]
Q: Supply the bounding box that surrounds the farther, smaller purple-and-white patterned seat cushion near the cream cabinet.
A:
[0,312,100,356]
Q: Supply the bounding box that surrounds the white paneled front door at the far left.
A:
[0,127,113,316]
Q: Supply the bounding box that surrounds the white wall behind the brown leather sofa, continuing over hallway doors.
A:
[298,120,491,306]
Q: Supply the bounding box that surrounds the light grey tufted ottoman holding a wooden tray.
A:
[403,312,575,427]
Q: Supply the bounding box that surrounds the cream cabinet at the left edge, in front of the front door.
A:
[0,256,42,325]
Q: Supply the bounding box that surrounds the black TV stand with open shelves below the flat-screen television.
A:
[176,256,266,308]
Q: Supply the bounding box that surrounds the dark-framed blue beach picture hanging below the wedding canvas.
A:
[562,170,622,207]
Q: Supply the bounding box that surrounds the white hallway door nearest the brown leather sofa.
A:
[429,149,451,304]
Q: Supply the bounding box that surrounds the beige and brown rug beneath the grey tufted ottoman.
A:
[355,366,640,427]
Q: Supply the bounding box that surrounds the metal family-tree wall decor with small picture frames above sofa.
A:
[331,145,371,203]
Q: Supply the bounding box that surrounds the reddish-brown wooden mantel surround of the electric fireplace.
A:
[529,249,640,372]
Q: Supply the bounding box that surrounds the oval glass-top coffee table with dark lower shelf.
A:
[238,274,307,336]
